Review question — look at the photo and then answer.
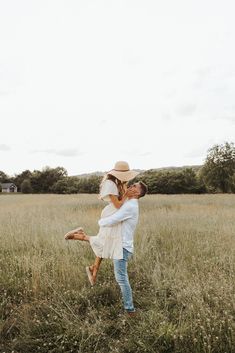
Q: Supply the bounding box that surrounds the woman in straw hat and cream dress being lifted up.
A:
[65,161,139,285]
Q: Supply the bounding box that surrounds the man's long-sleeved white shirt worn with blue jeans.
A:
[98,199,139,253]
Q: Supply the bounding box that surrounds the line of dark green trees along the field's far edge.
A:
[0,142,235,194]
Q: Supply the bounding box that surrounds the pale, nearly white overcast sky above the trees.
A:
[0,0,235,175]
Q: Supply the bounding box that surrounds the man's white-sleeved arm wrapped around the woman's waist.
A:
[98,202,133,227]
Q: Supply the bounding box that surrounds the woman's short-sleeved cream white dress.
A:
[90,180,123,259]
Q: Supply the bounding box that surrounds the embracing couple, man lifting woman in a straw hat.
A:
[65,161,147,315]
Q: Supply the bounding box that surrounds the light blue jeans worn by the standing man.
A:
[113,249,135,311]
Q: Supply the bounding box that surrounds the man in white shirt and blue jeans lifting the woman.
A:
[98,182,147,316]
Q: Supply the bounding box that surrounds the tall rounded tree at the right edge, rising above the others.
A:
[201,142,235,192]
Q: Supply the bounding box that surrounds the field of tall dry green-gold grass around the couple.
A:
[0,195,235,353]
